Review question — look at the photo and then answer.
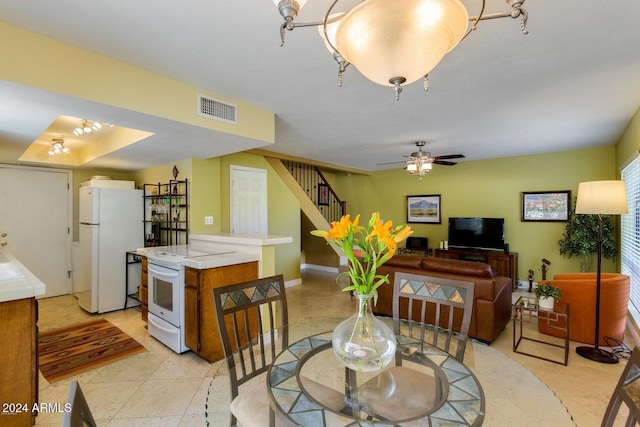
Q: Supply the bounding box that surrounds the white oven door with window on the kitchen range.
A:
[148,263,184,328]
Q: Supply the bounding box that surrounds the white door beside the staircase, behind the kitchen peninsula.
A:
[230,165,267,236]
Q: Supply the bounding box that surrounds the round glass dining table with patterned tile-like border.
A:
[266,317,485,427]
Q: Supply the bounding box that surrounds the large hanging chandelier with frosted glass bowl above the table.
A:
[273,0,528,101]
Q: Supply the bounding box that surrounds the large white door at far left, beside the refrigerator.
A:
[0,165,72,297]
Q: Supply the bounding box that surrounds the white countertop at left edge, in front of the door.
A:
[0,249,46,302]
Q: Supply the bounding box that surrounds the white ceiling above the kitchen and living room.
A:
[0,0,640,170]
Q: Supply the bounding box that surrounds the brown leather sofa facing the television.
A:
[373,256,512,343]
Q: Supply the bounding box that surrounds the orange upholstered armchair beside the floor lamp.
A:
[538,273,631,345]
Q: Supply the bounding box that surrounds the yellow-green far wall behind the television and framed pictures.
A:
[336,146,617,280]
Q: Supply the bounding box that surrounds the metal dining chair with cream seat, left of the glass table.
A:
[213,275,344,427]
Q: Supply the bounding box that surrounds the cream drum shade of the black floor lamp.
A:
[576,181,629,215]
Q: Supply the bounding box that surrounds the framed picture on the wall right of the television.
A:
[522,190,571,222]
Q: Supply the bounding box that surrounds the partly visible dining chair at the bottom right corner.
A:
[602,347,640,427]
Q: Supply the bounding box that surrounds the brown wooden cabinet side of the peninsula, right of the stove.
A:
[184,261,259,362]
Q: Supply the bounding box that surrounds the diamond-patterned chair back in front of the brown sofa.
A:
[393,272,475,362]
